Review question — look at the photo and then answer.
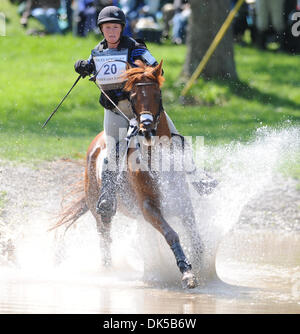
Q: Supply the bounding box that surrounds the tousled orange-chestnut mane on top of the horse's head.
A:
[124,60,165,91]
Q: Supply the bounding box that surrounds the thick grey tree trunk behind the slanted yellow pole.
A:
[183,0,237,79]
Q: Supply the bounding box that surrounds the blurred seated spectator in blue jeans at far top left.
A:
[21,0,61,34]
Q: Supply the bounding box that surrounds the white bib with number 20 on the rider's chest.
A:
[93,50,128,89]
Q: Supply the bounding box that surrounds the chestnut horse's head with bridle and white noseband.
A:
[124,61,164,140]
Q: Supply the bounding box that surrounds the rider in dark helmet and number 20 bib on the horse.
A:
[75,6,216,219]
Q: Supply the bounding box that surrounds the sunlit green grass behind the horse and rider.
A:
[0,0,300,161]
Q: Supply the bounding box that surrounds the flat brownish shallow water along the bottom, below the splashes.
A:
[0,232,300,314]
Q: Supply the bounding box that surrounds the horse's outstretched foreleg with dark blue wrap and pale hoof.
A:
[142,199,196,288]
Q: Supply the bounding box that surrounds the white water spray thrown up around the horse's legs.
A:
[1,126,300,286]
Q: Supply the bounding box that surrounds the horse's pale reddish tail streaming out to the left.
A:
[49,174,89,231]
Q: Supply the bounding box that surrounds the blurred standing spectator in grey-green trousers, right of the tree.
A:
[256,0,285,49]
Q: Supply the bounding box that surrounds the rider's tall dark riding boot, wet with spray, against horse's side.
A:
[96,170,118,223]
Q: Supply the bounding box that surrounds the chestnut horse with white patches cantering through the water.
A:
[56,62,204,288]
